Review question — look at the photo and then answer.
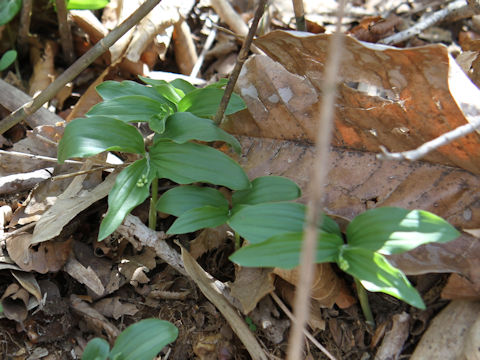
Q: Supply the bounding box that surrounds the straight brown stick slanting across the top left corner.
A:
[0,0,161,134]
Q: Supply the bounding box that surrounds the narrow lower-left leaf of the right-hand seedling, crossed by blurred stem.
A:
[229,231,343,269]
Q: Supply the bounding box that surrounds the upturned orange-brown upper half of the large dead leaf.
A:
[228,31,480,173]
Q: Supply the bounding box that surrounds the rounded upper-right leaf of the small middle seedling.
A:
[232,176,302,206]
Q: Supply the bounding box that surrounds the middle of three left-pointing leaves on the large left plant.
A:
[87,95,175,122]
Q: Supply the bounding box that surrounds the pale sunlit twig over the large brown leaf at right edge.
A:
[377,116,480,161]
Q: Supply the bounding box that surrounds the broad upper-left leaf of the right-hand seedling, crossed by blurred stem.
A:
[228,202,341,244]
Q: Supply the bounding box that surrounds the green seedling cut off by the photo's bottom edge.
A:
[82,319,178,360]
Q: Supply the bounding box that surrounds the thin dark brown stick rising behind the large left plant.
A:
[214,0,267,124]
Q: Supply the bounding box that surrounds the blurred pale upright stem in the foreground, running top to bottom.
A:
[287,0,346,360]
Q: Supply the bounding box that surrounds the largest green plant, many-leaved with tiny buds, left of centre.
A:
[58,78,250,240]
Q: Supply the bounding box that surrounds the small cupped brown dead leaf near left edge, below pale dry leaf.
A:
[6,233,72,274]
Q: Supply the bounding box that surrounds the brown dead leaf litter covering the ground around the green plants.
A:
[0,1,480,359]
